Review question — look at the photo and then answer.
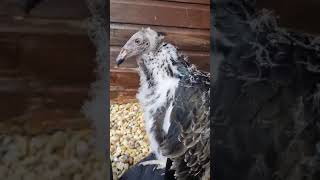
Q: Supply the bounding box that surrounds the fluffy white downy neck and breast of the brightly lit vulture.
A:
[137,44,179,165]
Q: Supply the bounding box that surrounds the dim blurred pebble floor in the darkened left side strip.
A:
[0,130,106,180]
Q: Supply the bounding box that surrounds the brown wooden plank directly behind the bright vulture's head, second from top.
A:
[110,23,210,52]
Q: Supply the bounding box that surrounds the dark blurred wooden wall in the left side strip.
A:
[0,0,95,133]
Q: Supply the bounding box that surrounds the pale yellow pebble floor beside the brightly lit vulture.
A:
[110,102,150,179]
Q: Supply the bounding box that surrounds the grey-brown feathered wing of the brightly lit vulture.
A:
[160,76,210,179]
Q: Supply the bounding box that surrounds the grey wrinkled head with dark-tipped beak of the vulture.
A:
[116,28,164,65]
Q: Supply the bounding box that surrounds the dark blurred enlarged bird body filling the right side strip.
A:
[210,0,320,180]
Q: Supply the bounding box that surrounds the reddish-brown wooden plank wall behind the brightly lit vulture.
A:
[110,0,210,99]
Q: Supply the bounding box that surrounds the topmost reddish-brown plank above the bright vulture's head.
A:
[110,0,210,29]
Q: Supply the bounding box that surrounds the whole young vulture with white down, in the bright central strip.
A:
[116,27,210,180]
